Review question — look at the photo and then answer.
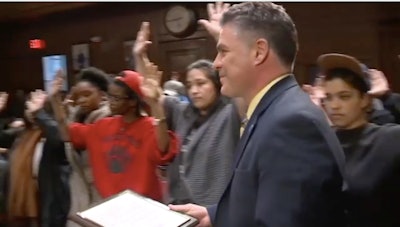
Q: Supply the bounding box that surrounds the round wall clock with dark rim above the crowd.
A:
[165,6,193,34]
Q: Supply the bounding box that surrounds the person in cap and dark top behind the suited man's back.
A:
[318,54,400,227]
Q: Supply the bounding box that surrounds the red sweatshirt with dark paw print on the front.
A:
[69,116,178,201]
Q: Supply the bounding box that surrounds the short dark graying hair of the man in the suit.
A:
[221,2,298,66]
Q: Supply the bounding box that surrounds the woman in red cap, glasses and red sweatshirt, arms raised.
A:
[53,70,178,201]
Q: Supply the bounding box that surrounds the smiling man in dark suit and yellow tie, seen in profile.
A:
[170,2,344,227]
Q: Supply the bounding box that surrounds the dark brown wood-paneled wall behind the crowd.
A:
[0,3,400,91]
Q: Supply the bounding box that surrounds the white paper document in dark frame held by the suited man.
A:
[77,191,191,227]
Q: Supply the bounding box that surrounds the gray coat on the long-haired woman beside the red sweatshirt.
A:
[164,97,240,206]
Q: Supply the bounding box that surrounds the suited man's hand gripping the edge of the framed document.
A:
[169,203,211,227]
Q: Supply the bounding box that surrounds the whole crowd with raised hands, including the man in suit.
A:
[0,2,400,227]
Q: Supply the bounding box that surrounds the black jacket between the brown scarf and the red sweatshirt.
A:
[36,110,71,227]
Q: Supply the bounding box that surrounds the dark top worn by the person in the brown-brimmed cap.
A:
[336,124,400,227]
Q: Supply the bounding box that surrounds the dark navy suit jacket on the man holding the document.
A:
[208,76,344,227]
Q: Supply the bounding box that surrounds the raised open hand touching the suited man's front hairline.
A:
[198,2,230,40]
